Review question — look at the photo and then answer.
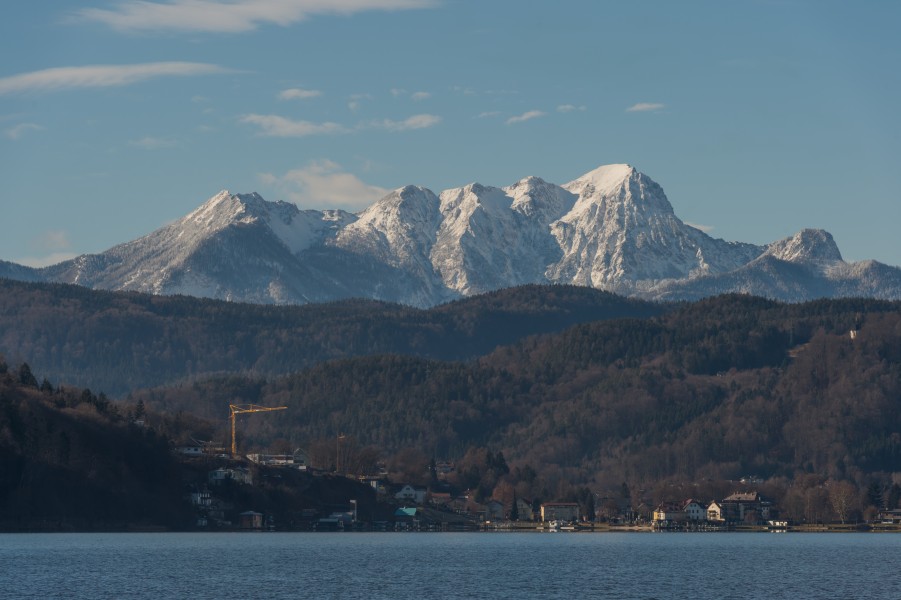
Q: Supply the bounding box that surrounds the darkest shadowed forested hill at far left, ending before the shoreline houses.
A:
[0,355,192,531]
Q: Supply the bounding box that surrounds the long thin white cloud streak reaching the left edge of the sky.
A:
[0,62,234,95]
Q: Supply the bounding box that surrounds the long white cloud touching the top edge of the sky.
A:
[74,0,436,33]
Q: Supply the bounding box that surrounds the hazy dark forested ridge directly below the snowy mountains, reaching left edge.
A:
[0,279,664,396]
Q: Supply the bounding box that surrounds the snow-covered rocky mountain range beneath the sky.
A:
[0,165,901,306]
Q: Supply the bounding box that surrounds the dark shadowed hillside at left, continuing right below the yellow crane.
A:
[0,355,393,532]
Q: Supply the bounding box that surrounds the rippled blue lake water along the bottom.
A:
[0,533,901,600]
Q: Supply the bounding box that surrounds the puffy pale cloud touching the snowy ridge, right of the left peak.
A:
[260,160,390,211]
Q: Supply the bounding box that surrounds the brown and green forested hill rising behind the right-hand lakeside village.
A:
[135,296,901,495]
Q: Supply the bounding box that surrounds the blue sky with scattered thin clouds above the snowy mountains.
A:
[0,0,901,266]
